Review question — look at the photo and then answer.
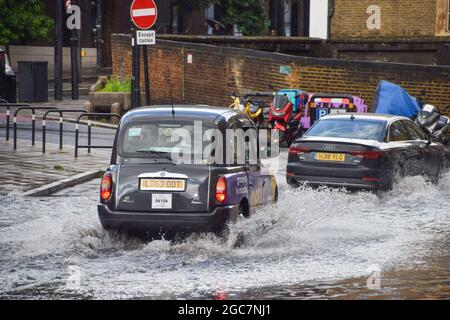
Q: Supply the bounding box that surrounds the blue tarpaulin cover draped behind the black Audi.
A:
[373,81,421,118]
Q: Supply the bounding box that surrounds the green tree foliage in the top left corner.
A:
[0,0,53,45]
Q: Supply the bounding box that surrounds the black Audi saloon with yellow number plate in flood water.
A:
[287,114,449,190]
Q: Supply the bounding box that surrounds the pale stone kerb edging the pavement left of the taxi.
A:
[23,170,104,197]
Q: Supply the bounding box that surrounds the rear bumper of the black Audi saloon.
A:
[287,164,390,190]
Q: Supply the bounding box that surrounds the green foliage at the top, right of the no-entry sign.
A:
[219,0,269,36]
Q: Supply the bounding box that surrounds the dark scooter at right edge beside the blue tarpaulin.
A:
[416,104,450,145]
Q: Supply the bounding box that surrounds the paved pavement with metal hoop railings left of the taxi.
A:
[0,97,115,195]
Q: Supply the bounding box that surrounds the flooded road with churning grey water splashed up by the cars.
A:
[0,173,450,299]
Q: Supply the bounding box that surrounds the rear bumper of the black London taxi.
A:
[98,204,239,233]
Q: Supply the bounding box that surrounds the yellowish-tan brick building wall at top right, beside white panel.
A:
[331,0,437,38]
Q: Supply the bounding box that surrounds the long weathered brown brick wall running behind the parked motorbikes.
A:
[112,35,450,117]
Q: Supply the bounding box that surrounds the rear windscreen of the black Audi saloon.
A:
[306,118,385,140]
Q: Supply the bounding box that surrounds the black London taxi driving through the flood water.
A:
[98,106,278,234]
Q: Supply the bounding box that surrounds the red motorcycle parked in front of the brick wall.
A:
[269,90,308,148]
